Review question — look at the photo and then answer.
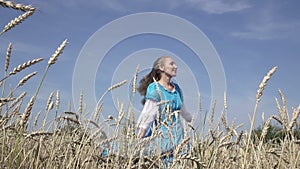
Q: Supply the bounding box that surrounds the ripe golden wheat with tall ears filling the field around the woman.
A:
[0,1,300,169]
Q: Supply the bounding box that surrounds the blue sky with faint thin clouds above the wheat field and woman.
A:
[0,0,300,129]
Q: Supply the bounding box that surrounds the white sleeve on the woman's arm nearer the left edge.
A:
[137,99,158,130]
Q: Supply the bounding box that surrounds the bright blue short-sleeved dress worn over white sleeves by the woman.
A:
[145,82,184,154]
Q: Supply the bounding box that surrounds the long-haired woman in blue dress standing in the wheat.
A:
[137,56,192,157]
